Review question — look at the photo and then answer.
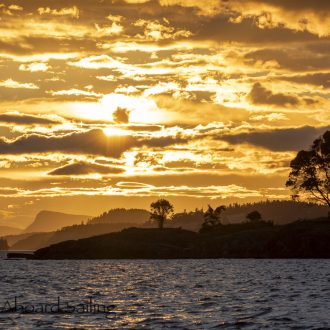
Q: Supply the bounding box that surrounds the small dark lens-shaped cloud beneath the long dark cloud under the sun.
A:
[48,162,124,175]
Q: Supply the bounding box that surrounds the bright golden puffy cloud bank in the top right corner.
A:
[178,0,330,36]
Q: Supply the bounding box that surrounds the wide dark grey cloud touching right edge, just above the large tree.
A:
[218,126,330,151]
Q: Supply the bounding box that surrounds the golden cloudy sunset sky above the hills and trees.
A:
[0,0,330,227]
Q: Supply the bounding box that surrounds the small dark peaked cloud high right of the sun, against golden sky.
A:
[248,83,299,106]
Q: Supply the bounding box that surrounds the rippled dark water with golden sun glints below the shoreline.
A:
[0,259,330,330]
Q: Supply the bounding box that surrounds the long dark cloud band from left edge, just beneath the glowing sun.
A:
[0,129,187,158]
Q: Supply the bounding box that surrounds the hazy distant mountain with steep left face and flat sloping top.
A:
[24,211,90,233]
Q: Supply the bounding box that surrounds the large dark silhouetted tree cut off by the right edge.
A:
[286,131,330,207]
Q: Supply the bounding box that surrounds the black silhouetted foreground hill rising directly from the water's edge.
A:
[34,219,330,259]
